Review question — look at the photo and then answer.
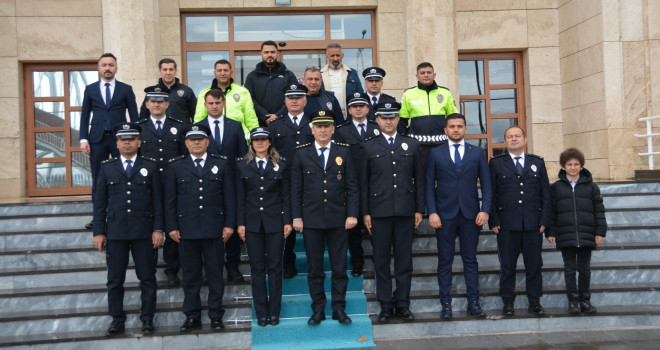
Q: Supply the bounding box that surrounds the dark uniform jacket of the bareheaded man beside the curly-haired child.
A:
[489,152,552,231]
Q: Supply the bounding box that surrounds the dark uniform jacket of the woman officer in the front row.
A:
[236,158,291,233]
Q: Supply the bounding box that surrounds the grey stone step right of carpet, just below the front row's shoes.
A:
[371,303,660,340]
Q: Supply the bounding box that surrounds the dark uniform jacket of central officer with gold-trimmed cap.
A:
[291,143,360,229]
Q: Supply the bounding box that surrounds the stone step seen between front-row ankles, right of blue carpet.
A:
[366,282,660,315]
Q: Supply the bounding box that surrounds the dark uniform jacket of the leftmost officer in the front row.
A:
[94,156,164,240]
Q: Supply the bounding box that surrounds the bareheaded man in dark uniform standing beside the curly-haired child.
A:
[489,126,552,316]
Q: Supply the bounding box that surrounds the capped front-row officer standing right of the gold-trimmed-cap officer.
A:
[359,102,425,322]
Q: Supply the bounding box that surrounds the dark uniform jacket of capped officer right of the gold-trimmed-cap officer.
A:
[360,134,424,217]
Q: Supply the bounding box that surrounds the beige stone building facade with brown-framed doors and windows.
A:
[0,0,660,199]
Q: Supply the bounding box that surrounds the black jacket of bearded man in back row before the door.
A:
[244,61,298,125]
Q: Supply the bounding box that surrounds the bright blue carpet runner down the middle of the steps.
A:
[252,234,376,350]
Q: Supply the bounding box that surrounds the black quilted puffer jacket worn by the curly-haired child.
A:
[545,169,607,249]
